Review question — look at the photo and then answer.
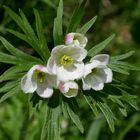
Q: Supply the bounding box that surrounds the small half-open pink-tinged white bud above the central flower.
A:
[65,33,88,48]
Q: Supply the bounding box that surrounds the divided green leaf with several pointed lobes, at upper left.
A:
[4,6,50,62]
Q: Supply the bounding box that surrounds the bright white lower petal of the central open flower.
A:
[57,62,84,82]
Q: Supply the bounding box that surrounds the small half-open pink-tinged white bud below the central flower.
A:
[58,81,78,98]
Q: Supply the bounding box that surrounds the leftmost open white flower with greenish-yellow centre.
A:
[21,65,57,98]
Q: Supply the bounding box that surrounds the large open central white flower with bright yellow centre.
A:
[47,45,87,82]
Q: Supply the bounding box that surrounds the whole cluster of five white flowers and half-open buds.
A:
[21,33,112,98]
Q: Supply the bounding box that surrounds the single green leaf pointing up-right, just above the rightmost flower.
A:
[88,34,115,57]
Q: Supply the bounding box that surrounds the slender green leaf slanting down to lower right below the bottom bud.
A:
[65,101,84,133]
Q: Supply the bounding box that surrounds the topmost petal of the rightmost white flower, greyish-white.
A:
[90,54,109,65]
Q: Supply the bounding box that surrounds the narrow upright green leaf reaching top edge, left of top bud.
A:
[53,0,63,45]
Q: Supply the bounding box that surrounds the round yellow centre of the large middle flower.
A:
[60,55,73,66]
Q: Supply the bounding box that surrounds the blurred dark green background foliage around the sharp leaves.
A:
[0,0,140,140]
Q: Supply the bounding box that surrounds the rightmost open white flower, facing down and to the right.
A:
[82,54,113,91]
